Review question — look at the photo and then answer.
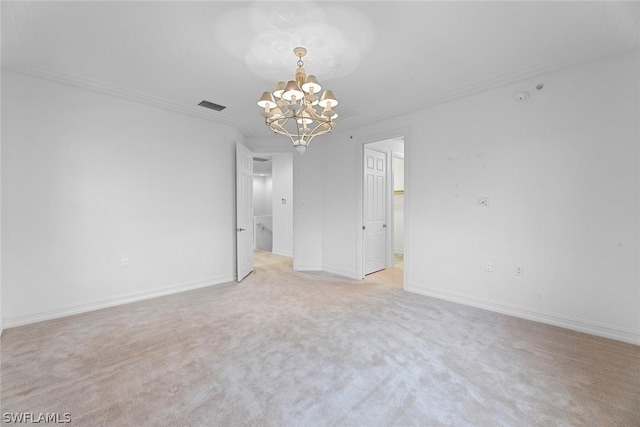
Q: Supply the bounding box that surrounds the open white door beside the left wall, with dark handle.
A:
[236,142,253,282]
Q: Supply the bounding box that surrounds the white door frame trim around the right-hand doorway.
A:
[356,128,412,288]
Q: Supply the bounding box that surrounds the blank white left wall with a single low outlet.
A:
[2,71,241,327]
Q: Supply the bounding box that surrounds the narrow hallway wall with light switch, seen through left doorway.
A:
[271,153,294,257]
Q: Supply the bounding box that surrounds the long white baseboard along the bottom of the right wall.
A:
[404,284,640,345]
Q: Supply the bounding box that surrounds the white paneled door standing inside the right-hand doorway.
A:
[363,147,387,275]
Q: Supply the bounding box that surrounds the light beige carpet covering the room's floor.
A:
[0,252,640,426]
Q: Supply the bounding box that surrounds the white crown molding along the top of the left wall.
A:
[5,67,253,136]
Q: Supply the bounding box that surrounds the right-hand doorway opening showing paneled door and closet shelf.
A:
[362,136,405,287]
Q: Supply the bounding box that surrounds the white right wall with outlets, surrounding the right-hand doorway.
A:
[321,51,640,344]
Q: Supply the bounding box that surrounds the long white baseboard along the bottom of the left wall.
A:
[2,276,235,328]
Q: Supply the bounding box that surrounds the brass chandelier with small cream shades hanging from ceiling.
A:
[258,47,338,154]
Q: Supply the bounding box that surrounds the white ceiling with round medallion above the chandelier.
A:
[2,1,640,137]
